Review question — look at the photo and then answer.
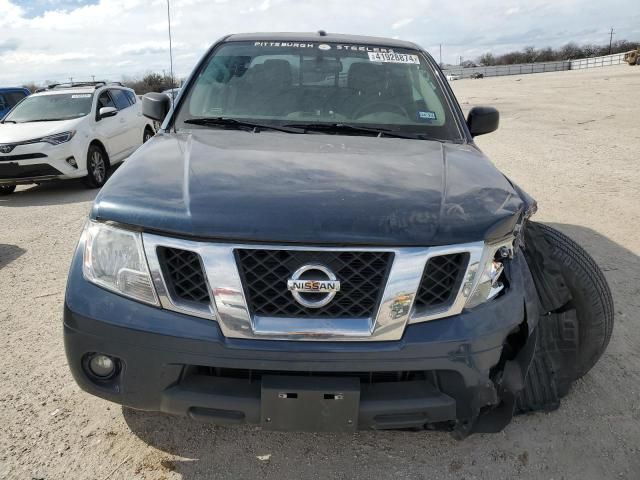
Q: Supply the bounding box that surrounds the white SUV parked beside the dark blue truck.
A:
[0,82,154,195]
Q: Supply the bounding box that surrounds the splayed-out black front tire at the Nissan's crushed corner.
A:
[516,222,614,413]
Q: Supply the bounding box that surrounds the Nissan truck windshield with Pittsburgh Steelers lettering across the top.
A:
[176,41,462,141]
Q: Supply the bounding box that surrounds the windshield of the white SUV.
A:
[4,93,93,123]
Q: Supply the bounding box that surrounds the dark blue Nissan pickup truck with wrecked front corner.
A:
[64,32,613,438]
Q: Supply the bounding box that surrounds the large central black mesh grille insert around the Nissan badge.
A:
[236,249,393,318]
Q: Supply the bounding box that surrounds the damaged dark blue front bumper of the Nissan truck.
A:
[64,246,538,436]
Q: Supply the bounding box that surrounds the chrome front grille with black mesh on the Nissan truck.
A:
[143,233,484,341]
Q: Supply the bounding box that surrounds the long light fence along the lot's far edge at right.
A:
[443,53,624,78]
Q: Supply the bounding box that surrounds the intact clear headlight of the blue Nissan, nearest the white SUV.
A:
[82,221,159,305]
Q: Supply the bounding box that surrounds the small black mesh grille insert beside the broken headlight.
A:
[415,252,469,310]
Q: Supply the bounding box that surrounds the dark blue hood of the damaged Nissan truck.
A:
[92,129,524,246]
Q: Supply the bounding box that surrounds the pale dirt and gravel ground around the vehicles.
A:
[0,66,640,480]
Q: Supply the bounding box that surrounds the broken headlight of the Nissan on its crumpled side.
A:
[462,239,513,308]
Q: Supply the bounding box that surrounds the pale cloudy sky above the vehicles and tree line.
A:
[0,0,640,86]
